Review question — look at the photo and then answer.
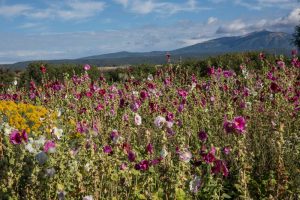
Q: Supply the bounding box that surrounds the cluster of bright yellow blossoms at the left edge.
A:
[0,101,54,133]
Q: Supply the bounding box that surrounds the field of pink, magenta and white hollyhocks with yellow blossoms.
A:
[0,54,300,200]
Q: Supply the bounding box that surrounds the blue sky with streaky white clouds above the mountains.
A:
[0,0,300,64]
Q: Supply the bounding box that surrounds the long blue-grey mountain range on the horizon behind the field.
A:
[5,30,294,68]
